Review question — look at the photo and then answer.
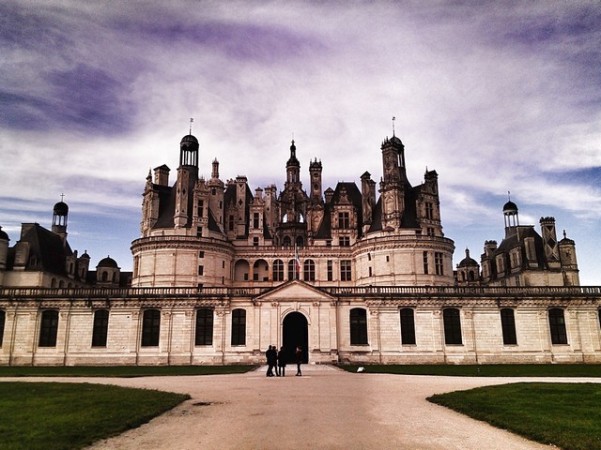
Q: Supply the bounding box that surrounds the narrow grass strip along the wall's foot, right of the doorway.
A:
[340,364,601,377]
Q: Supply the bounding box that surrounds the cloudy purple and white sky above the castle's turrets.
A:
[0,0,601,285]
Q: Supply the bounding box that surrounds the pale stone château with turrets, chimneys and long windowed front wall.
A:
[0,131,601,365]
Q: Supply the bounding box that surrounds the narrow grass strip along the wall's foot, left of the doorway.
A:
[0,366,256,378]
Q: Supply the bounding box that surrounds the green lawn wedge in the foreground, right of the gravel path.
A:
[428,383,601,450]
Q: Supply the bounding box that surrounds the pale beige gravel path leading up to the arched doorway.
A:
[4,365,600,450]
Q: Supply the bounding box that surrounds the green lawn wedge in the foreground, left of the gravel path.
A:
[0,383,190,449]
